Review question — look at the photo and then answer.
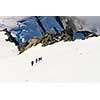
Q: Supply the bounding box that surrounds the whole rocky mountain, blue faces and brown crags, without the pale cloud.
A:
[4,16,97,53]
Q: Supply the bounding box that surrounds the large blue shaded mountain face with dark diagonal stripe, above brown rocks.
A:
[10,16,63,44]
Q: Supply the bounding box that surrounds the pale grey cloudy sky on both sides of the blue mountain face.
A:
[0,16,100,32]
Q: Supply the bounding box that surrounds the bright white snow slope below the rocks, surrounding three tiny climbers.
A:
[0,33,100,82]
